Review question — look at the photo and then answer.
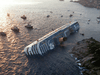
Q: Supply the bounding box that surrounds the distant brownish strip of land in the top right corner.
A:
[78,0,100,9]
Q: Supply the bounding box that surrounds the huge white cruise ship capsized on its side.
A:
[24,21,80,55]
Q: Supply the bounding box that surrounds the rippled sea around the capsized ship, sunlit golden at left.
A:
[0,0,100,75]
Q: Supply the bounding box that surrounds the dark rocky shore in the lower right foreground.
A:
[70,38,100,75]
